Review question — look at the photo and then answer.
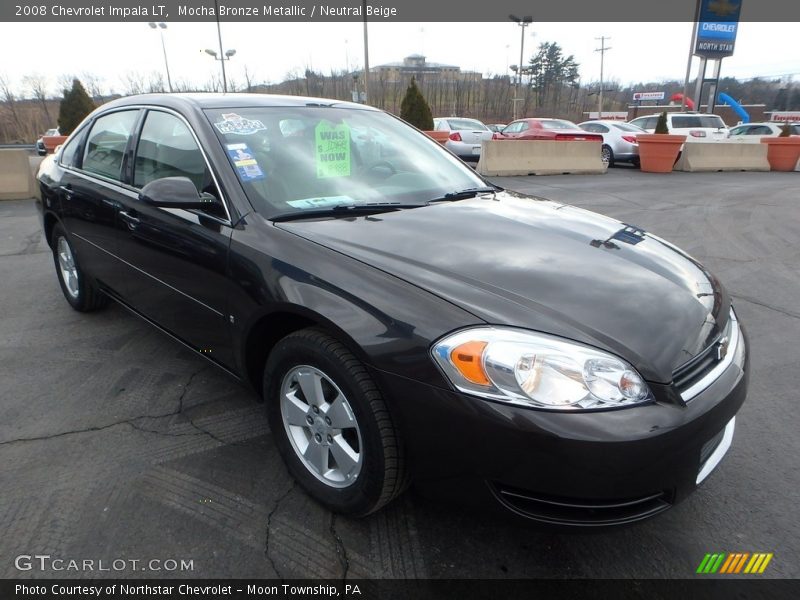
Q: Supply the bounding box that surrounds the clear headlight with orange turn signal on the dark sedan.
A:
[431,327,653,410]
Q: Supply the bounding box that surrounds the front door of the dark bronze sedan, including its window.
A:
[118,109,233,367]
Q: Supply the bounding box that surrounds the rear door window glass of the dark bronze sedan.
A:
[81,109,139,181]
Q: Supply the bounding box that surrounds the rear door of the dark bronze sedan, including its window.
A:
[59,109,140,294]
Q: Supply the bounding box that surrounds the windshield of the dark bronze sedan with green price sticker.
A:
[205,105,487,219]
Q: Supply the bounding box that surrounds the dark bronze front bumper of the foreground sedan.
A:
[374,326,749,526]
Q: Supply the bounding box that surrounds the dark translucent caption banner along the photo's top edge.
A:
[0,0,800,22]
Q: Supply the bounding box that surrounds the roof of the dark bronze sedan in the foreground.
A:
[94,93,378,112]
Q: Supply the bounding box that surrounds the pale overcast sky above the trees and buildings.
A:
[0,22,800,95]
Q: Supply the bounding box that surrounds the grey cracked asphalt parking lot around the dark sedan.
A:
[0,168,800,578]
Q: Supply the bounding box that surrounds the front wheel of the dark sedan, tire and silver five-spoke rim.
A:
[264,329,408,516]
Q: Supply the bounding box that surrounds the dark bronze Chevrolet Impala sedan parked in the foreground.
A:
[38,94,749,526]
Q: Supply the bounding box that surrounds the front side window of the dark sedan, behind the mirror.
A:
[133,110,219,197]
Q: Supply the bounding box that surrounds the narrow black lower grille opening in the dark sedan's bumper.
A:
[490,483,672,526]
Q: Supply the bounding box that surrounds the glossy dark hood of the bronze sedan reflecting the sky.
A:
[276,192,730,383]
